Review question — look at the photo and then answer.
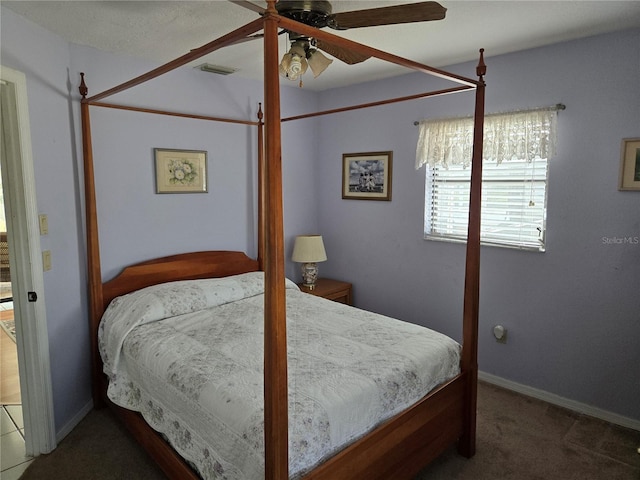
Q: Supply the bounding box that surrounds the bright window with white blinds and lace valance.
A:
[416,107,558,251]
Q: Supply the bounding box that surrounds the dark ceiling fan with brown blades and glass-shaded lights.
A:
[229,0,447,80]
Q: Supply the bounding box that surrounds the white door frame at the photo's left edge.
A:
[0,66,56,456]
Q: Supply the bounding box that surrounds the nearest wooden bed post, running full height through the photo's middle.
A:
[264,0,289,480]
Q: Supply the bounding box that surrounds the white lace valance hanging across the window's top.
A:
[416,107,558,169]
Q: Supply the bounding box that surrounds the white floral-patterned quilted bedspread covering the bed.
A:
[99,272,460,479]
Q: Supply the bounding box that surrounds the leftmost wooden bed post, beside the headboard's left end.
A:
[79,73,104,407]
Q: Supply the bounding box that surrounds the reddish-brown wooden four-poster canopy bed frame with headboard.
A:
[80,0,486,480]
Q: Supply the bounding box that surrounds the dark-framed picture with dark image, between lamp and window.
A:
[342,152,393,201]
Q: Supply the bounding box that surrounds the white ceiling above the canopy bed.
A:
[1,0,640,90]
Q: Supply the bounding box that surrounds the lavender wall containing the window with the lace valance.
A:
[316,30,640,420]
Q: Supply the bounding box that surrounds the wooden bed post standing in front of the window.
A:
[458,49,487,457]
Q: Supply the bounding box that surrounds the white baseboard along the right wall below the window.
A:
[478,372,640,431]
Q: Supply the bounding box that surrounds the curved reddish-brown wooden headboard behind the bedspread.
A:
[102,250,259,309]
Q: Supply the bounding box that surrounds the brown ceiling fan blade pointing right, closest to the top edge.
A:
[328,2,447,30]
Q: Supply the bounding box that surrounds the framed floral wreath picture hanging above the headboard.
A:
[154,148,207,193]
